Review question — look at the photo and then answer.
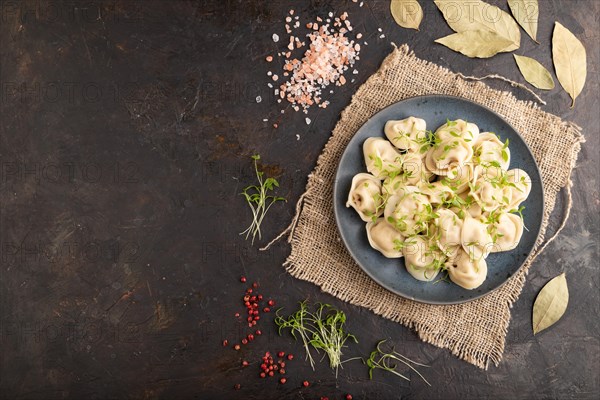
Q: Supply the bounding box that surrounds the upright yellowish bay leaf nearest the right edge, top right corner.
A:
[552,22,587,108]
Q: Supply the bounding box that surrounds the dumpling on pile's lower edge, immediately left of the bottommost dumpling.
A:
[402,235,446,281]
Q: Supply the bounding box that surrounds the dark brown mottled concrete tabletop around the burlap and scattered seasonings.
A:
[0,0,600,399]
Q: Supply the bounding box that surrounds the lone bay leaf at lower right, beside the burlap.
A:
[533,272,569,335]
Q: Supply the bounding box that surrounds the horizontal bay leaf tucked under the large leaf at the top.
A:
[435,30,512,58]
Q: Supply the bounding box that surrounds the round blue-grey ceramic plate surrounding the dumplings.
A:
[333,96,544,304]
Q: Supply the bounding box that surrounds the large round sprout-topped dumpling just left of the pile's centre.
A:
[383,186,431,236]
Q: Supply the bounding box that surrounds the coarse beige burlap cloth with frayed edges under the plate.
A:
[264,45,584,369]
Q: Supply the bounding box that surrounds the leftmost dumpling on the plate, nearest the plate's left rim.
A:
[346,173,383,222]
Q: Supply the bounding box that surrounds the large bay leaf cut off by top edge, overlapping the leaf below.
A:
[435,0,521,54]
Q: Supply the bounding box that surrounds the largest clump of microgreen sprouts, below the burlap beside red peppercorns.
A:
[275,301,358,377]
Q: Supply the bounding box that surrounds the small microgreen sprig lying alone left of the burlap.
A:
[240,154,287,244]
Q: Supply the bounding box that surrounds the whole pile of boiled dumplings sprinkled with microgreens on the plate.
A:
[346,117,531,289]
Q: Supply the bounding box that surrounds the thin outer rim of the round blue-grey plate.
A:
[332,94,546,305]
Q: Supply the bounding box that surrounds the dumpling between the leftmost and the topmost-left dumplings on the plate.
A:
[363,137,402,179]
